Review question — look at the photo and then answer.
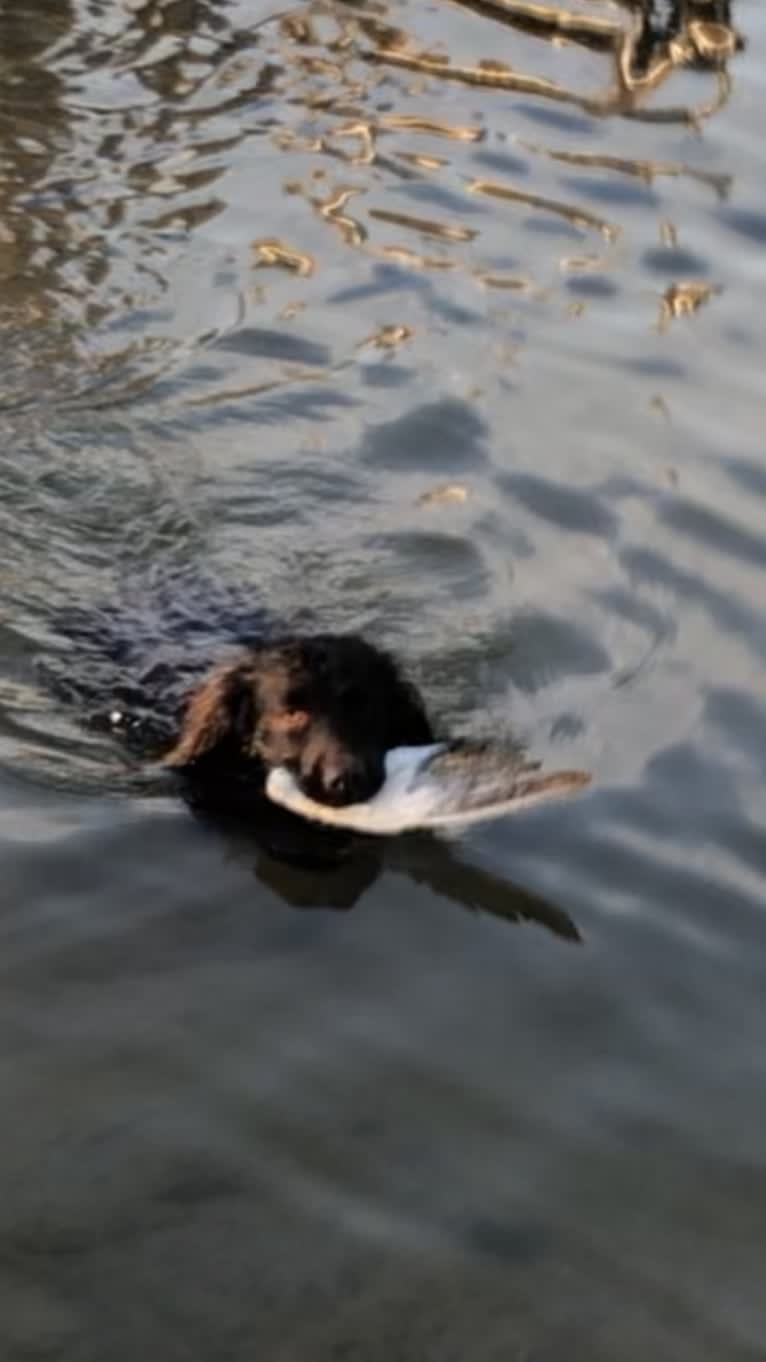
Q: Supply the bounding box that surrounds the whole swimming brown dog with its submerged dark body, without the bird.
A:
[38,582,433,865]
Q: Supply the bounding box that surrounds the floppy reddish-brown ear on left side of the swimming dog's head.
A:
[162,662,255,767]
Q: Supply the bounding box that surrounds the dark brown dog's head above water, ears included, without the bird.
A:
[165,635,433,805]
